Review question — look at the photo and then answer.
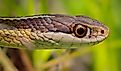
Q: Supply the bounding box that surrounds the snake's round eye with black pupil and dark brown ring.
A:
[74,24,87,38]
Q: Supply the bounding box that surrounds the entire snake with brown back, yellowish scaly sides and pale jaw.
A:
[0,14,109,49]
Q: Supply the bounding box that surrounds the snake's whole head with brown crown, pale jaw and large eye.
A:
[40,15,109,48]
